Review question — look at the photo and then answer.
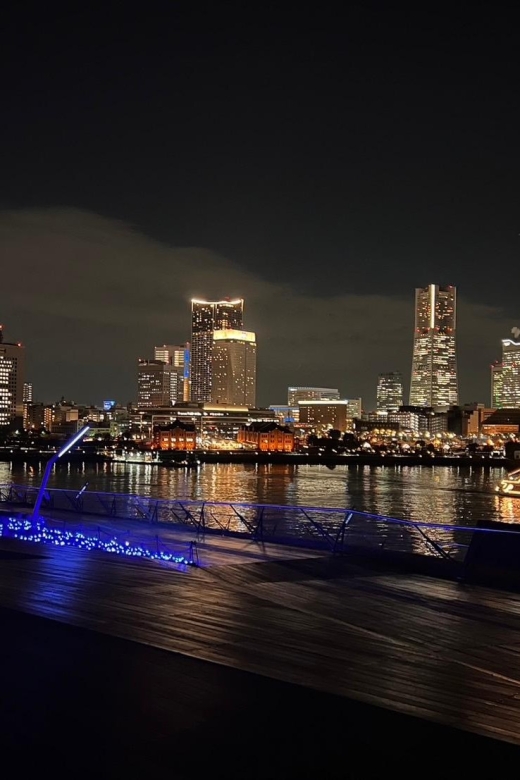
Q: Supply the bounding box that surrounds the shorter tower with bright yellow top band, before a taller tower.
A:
[211,328,256,406]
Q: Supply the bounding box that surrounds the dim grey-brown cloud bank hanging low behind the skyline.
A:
[0,208,519,408]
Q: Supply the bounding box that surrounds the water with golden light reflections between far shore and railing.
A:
[0,463,520,525]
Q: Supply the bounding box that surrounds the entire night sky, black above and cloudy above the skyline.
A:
[0,7,520,408]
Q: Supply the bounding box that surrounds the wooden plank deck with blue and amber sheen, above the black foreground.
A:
[0,524,520,756]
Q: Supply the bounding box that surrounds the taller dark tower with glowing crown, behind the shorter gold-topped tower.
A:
[191,298,244,402]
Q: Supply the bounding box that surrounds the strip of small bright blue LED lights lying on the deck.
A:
[0,517,195,566]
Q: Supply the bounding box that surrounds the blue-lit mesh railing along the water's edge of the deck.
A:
[0,484,476,561]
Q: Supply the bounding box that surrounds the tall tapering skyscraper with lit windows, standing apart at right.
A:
[410,284,459,407]
